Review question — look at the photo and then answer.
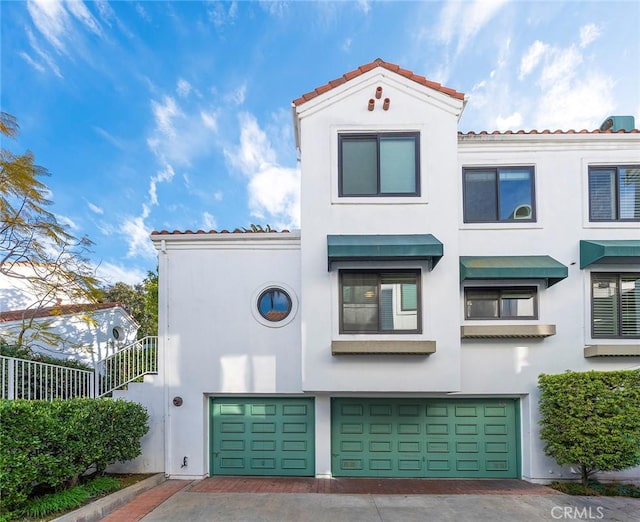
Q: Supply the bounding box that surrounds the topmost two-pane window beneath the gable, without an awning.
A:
[338,132,420,196]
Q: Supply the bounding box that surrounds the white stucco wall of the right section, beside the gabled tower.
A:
[457,134,640,480]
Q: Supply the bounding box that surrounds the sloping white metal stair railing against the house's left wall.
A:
[95,337,158,397]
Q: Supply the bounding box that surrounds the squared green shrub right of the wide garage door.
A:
[538,370,640,486]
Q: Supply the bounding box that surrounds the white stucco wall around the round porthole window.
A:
[154,232,302,478]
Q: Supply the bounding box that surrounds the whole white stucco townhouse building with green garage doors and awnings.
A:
[136,60,640,481]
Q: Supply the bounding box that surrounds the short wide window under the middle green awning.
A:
[464,287,538,319]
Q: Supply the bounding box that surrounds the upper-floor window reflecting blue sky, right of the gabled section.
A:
[462,167,536,223]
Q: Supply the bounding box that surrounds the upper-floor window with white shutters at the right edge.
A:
[589,165,640,221]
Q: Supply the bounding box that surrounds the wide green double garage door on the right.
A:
[331,398,519,478]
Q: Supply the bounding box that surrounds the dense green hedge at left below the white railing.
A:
[0,399,149,511]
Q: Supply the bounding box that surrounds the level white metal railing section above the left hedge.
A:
[0,355,95,400]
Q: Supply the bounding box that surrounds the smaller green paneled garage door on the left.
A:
[211,397,315,476]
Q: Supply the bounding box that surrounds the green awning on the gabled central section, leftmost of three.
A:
[327,234,444,270]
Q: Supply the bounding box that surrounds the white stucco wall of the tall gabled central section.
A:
[297,69,462,392]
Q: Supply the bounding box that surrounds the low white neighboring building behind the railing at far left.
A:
[0,303,140,365]
